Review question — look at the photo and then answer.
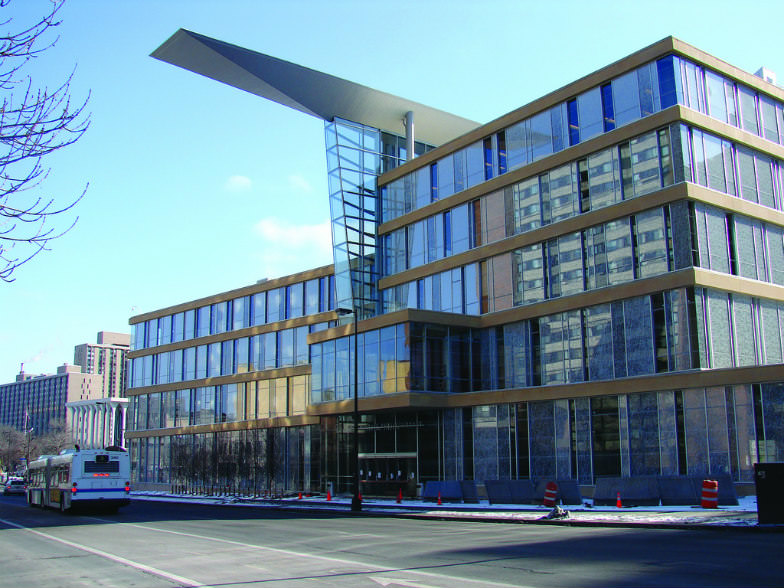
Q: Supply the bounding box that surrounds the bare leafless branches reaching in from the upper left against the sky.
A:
[0,0,90,282]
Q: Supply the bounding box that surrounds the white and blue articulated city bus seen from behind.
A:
[27,446,131,512]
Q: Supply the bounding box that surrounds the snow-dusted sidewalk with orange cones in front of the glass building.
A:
[131,492,772,532]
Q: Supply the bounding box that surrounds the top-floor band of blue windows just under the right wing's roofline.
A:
[381,56,784,222]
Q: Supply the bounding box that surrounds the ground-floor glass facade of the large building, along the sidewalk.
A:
[130,383,784,484]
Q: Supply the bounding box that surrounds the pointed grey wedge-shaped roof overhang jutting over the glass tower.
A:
[152,29,480,146]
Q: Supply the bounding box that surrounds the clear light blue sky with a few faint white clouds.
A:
[0,0,784,383]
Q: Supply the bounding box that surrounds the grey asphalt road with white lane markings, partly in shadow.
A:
[0,496,784,588]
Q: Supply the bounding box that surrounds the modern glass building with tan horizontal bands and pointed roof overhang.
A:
[127,35,784,494]
